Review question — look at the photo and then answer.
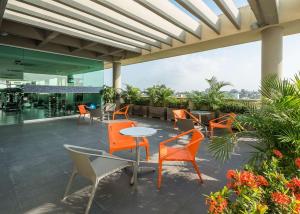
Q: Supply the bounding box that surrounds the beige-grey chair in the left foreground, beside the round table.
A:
[63,145,136,214]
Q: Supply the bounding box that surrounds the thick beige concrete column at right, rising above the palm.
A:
[261,26,283,80]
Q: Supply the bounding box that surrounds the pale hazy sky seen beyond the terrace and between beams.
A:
[104,0,300,91]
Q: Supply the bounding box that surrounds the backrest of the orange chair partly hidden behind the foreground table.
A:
[108,121,136,145]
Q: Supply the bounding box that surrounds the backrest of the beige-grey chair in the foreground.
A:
[64,145,96,181]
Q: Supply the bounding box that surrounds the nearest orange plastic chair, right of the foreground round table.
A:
[157,129,204,189]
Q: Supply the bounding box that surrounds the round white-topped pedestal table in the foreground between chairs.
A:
[120,127,157,186]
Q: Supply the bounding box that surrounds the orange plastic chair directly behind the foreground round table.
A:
[108,121,149,160]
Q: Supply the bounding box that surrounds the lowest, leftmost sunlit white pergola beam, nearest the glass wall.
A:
[7,0,150,50]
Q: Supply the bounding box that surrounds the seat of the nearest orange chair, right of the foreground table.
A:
[161,146,194,161]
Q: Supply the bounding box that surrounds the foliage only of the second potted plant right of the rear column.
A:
[146,85,174,107]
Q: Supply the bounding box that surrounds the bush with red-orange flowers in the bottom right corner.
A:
[207,157,300,214]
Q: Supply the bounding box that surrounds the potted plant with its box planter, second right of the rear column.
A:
[146,85,174,119]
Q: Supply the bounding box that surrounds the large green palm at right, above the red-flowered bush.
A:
[209,73,300,166]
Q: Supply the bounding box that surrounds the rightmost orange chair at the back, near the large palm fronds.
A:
[209,113,236,136]
